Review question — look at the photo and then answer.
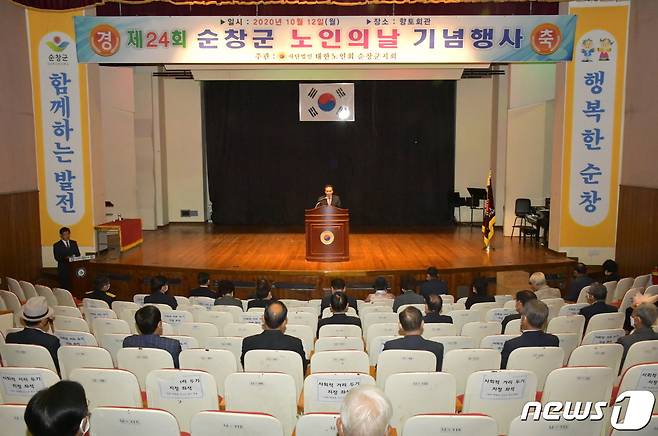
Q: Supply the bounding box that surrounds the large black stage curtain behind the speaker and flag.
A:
[204,81,454,226]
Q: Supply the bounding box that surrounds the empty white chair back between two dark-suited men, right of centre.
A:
[442,348,500,395]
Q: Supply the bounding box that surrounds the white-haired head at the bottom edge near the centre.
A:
[336,386,393,436]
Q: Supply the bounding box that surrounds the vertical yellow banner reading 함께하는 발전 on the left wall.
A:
[27,10,95,264]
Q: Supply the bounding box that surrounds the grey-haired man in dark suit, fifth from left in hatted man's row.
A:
[500,300,560,369]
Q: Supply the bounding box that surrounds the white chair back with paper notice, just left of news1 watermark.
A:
[463,369,537,434]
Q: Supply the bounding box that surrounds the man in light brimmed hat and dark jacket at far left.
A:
[5,297,60,372]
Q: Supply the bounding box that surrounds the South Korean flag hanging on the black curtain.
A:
[299,83,354,121]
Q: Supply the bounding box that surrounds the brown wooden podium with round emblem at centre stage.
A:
[304,206,350,262]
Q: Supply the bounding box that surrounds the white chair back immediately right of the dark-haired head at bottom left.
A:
[69,368,142,410]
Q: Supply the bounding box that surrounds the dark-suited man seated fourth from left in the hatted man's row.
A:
[383,307,443,371]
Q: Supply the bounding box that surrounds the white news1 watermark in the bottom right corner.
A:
[521,391,656,431]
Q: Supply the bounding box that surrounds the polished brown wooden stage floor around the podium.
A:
[89,224,575,299]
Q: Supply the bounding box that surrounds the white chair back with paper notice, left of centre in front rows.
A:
[146,369,219,432]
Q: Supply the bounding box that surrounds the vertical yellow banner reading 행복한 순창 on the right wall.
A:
[559,2,630,262]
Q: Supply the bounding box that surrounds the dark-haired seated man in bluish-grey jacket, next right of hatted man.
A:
[123,306,181,368]
